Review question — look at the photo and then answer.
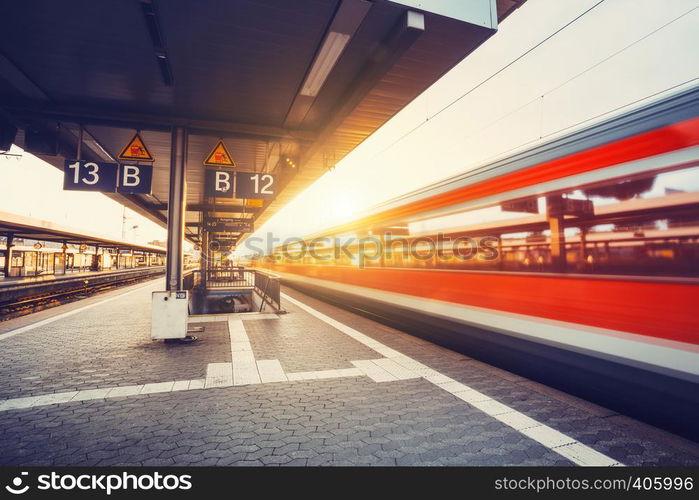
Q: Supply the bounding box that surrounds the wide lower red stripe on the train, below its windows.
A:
[271,265,699,344]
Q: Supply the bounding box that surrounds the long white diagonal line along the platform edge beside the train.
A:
[281,293,622,466]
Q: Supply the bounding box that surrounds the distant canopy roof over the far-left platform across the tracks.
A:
[0,212,165,254]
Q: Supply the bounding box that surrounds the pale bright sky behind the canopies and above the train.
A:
[0,0,699,250]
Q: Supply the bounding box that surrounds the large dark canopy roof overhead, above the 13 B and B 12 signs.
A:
[0,0,523,245]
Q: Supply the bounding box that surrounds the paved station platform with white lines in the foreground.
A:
[0,280,699,466]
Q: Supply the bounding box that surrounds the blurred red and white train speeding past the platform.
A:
[257,88,699,439]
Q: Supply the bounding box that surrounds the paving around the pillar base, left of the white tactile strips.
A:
[0,280,230,400]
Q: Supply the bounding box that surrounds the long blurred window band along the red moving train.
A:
[274,166,699,276]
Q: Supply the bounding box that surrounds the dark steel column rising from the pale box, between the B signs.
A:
[166,127,187,292]
